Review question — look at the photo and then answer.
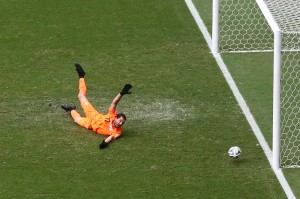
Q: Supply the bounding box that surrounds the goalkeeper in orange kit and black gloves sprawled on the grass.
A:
[61,63,132,149]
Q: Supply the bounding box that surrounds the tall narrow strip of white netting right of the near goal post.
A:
[280,33,300,167]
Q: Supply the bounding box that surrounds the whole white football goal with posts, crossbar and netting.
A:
[211,0,300,169]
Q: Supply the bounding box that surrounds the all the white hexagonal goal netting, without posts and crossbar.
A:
[219,0,300,167]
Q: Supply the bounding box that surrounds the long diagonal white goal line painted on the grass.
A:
[185,0,296,199]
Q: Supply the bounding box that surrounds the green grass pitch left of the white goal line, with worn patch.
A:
[0,0,292,199]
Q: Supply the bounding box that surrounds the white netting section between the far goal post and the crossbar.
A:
[219,0,274,52]
